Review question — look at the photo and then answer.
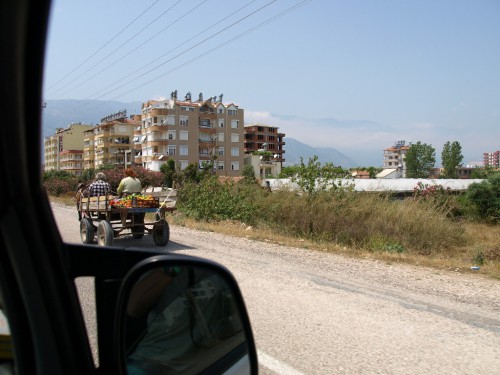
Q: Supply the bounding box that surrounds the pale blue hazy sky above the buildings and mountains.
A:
[44,0,500,166]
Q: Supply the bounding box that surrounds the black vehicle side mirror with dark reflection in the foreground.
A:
[115,255,258,375]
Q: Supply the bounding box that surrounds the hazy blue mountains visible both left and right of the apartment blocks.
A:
[42,99,357,168]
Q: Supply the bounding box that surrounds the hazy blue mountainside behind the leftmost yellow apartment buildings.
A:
[42,99,142,137]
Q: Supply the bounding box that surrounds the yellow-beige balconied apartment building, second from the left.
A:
[83,110,141,169]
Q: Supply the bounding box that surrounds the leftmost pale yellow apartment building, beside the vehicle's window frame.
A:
[44,123,93,176]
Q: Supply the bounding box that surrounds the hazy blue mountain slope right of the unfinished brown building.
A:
[284,137,358,168]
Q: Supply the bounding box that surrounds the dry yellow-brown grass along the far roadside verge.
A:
[50,194,500,280]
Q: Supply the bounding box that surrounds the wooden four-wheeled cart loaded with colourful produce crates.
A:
[77,195,175,246]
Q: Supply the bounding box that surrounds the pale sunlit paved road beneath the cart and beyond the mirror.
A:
[53,206,500,375]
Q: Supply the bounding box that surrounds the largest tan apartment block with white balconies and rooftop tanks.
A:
[139,91,244,176]
